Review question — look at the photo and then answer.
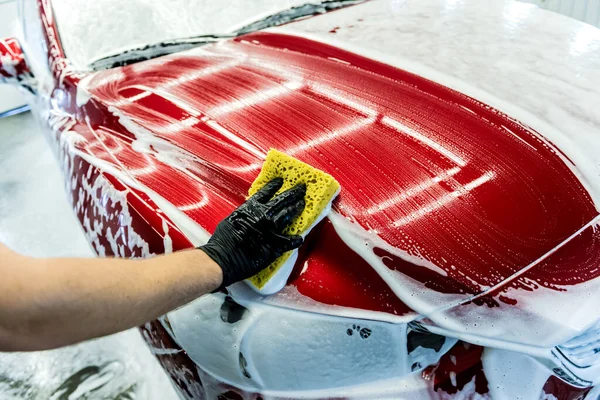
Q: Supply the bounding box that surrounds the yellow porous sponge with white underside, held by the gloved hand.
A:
[247,149,340,295]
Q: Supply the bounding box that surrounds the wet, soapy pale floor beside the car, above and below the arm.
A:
[0,114,178,400]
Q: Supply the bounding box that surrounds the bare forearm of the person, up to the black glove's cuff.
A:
[0,250,222,350]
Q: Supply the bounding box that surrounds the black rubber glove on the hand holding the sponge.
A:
[199,178,306,288]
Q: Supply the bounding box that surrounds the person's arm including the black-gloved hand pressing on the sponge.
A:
[0,180,305,351]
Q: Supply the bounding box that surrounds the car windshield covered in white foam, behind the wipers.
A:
[52,0,357,70]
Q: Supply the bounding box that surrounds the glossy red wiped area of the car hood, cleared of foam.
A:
[84,33,598,308]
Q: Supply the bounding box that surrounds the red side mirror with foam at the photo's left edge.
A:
[0,38,33,86]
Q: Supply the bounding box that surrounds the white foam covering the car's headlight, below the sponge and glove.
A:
[168,293,454,399]
